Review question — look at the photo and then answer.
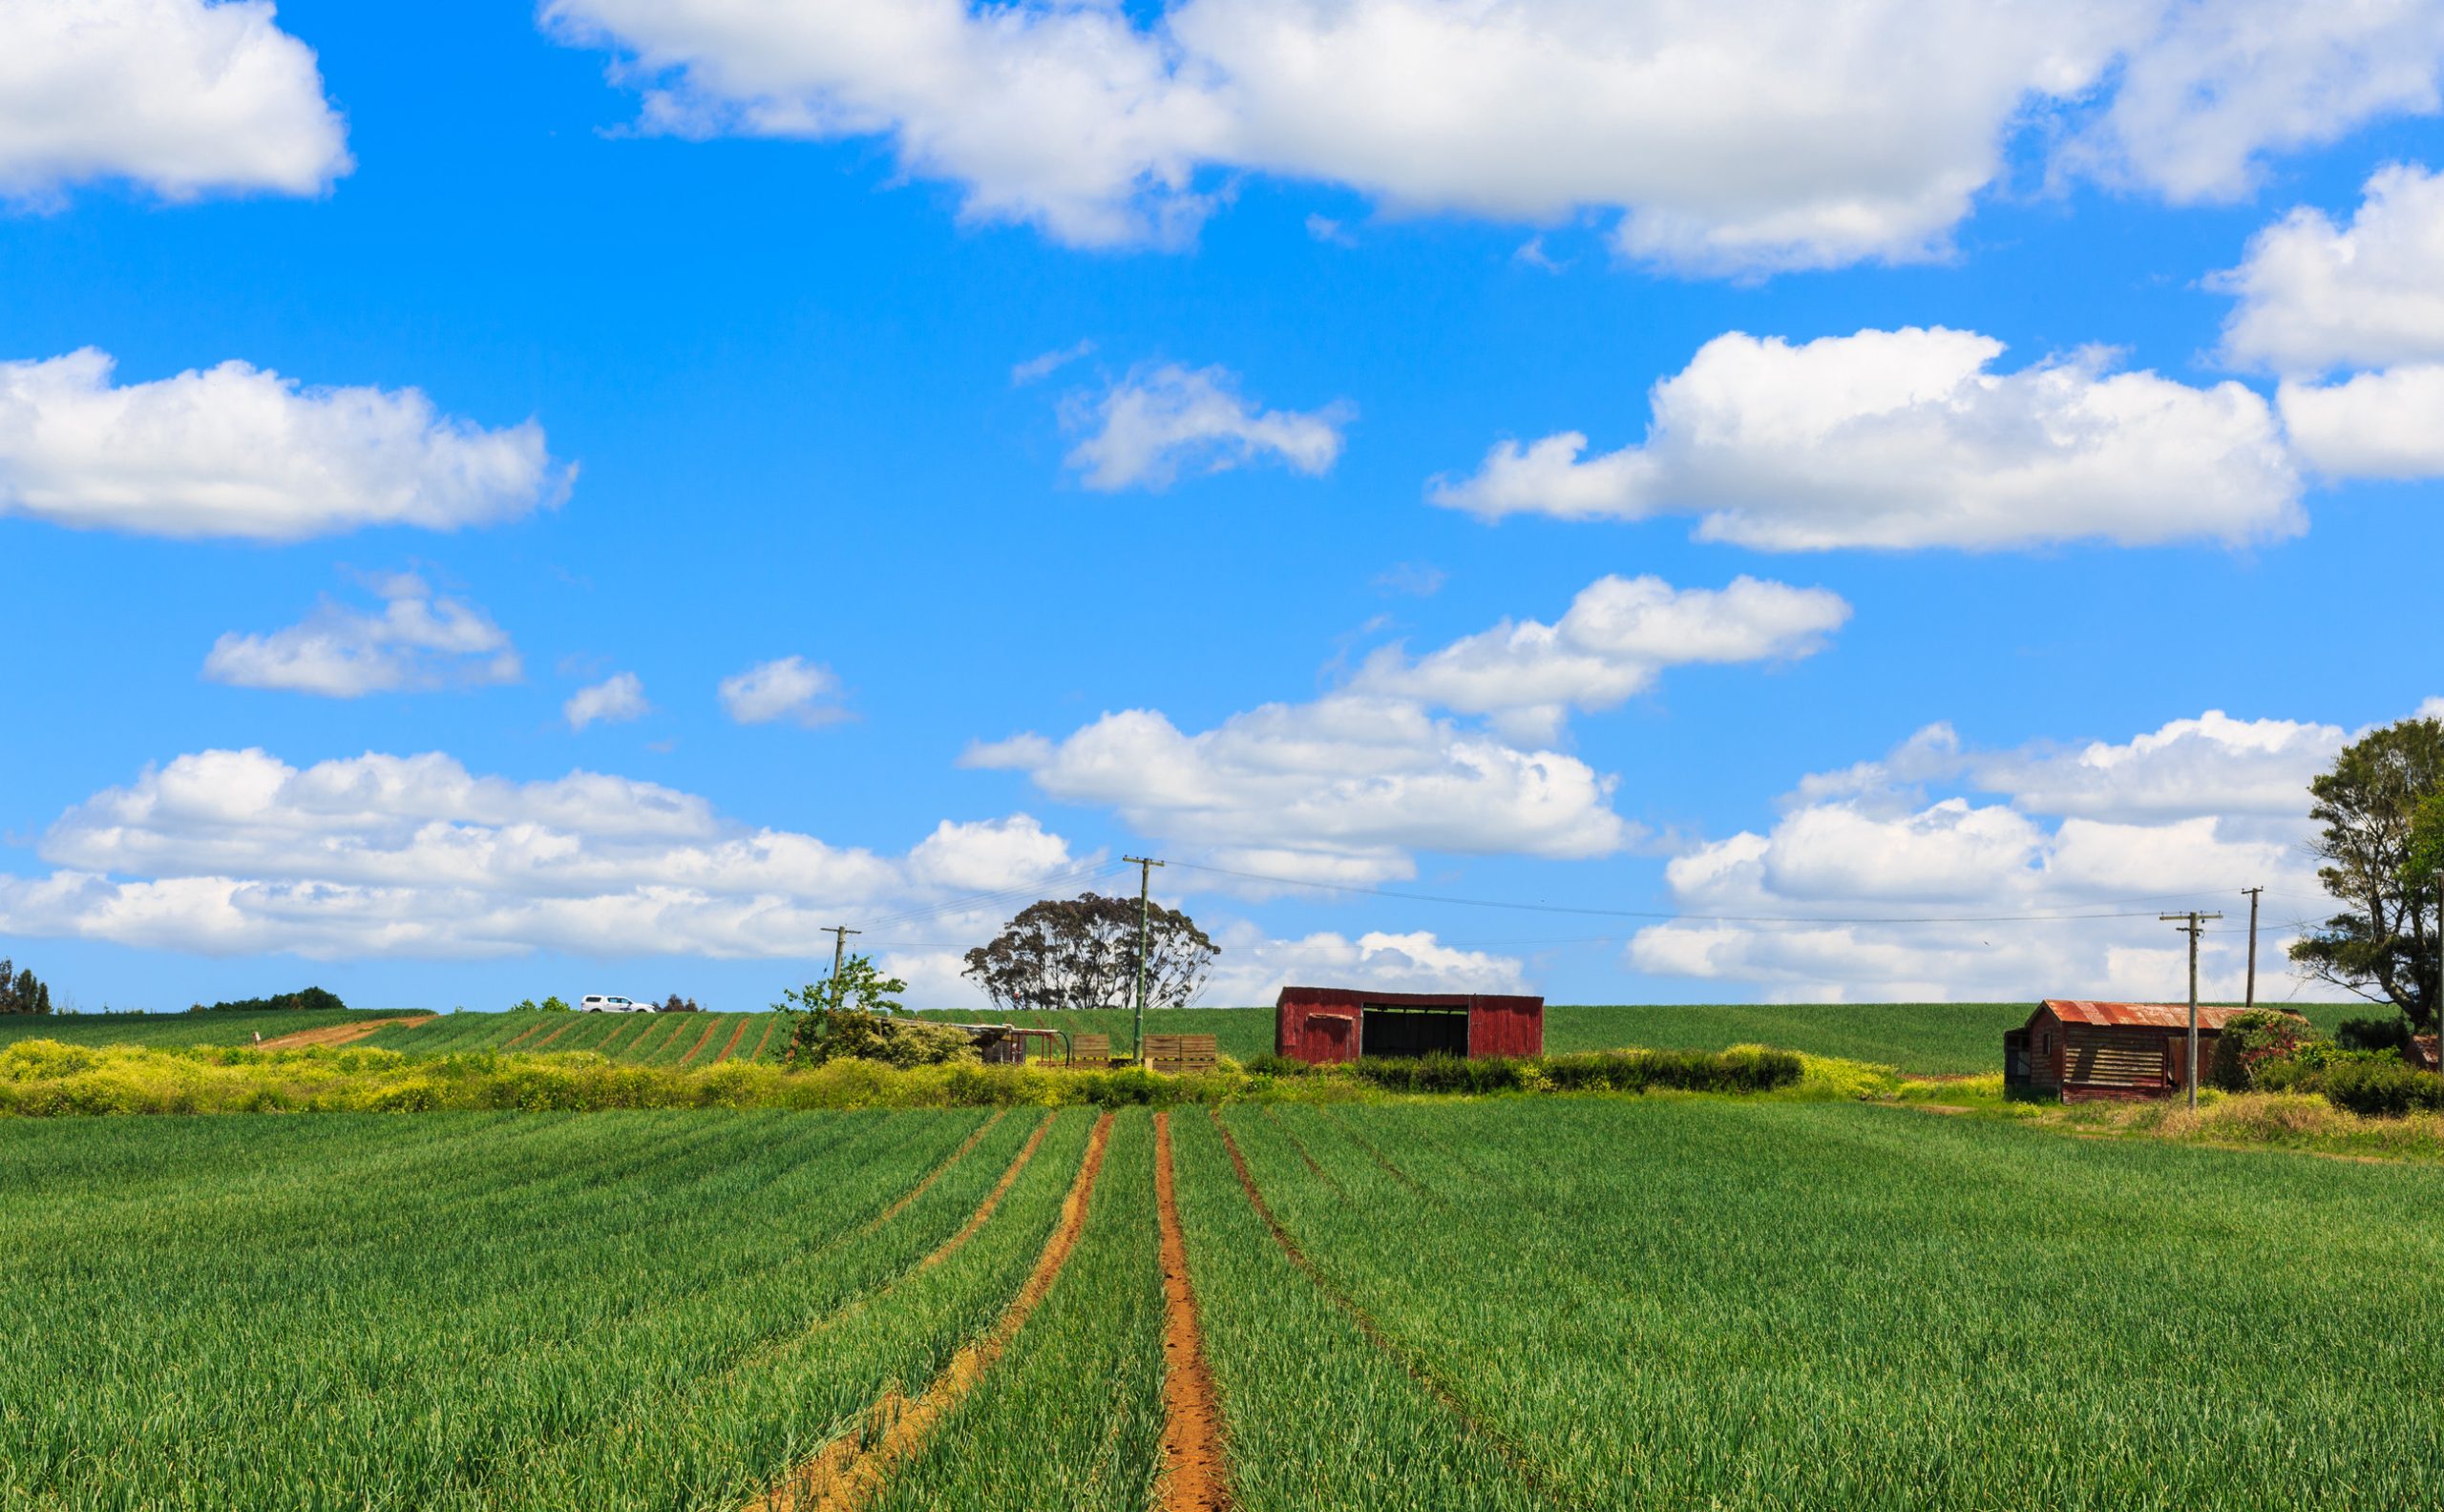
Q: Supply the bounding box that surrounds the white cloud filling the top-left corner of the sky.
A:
[0,0,352,202]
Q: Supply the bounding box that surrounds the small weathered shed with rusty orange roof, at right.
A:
[2002,997,2277,1102]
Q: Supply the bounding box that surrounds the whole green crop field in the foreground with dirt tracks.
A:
[0,1100,2444,1512]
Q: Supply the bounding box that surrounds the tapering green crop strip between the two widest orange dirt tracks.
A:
[873,1109,1164,1512]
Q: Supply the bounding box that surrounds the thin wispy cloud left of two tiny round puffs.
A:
[202,572,520,699]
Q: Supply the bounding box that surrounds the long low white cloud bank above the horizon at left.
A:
[0,750,1073,960]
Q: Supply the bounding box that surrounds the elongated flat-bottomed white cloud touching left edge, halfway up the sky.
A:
[0,349,575,540]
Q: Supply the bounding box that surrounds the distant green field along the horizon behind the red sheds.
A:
[14,1004,2373,1075]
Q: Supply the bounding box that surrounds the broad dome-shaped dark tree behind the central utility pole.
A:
[960,892,1222,1011]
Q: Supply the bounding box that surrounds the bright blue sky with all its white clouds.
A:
[0,0,2444,1009]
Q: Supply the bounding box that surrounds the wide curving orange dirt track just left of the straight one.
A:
[755,1114,1112,1512]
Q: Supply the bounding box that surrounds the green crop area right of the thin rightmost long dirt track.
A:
[1249,1100,2444,1507]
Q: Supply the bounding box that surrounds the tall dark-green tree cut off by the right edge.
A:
[2290,718,2444,1031]
